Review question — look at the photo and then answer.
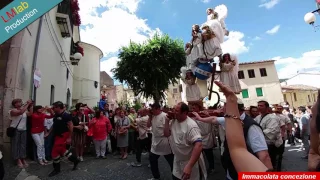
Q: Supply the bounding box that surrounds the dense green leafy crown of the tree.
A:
[112,35,186,101]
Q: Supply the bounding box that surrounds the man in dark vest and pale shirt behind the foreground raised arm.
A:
[194,99,273,180]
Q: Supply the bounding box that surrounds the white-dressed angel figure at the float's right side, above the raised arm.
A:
[219,53,241,94]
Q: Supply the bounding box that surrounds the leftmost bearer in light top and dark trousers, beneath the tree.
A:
[131,109,149,167]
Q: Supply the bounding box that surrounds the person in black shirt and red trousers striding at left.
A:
[49,101,79,177]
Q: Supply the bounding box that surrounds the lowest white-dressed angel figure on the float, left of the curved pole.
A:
[181,67,202,104]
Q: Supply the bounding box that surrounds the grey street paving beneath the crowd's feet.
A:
[5,141,307,180]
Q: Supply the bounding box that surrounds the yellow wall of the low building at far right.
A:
[282,90,318,108]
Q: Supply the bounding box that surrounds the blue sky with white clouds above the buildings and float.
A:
[79,0,320,83]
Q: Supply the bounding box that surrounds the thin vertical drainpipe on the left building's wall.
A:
[29,16,43,103]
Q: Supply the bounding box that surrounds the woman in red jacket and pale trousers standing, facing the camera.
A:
[89,110,112,159]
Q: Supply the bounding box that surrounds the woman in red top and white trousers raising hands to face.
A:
[31,106,53,165]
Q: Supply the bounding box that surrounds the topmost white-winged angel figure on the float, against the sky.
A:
[206,4,229,36]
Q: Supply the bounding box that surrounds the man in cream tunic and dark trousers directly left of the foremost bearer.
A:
[147,102,174,180]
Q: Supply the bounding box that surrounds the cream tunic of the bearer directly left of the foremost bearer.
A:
[151,112,172,155]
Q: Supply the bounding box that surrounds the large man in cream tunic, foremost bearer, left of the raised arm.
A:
[164,102,207,180]
